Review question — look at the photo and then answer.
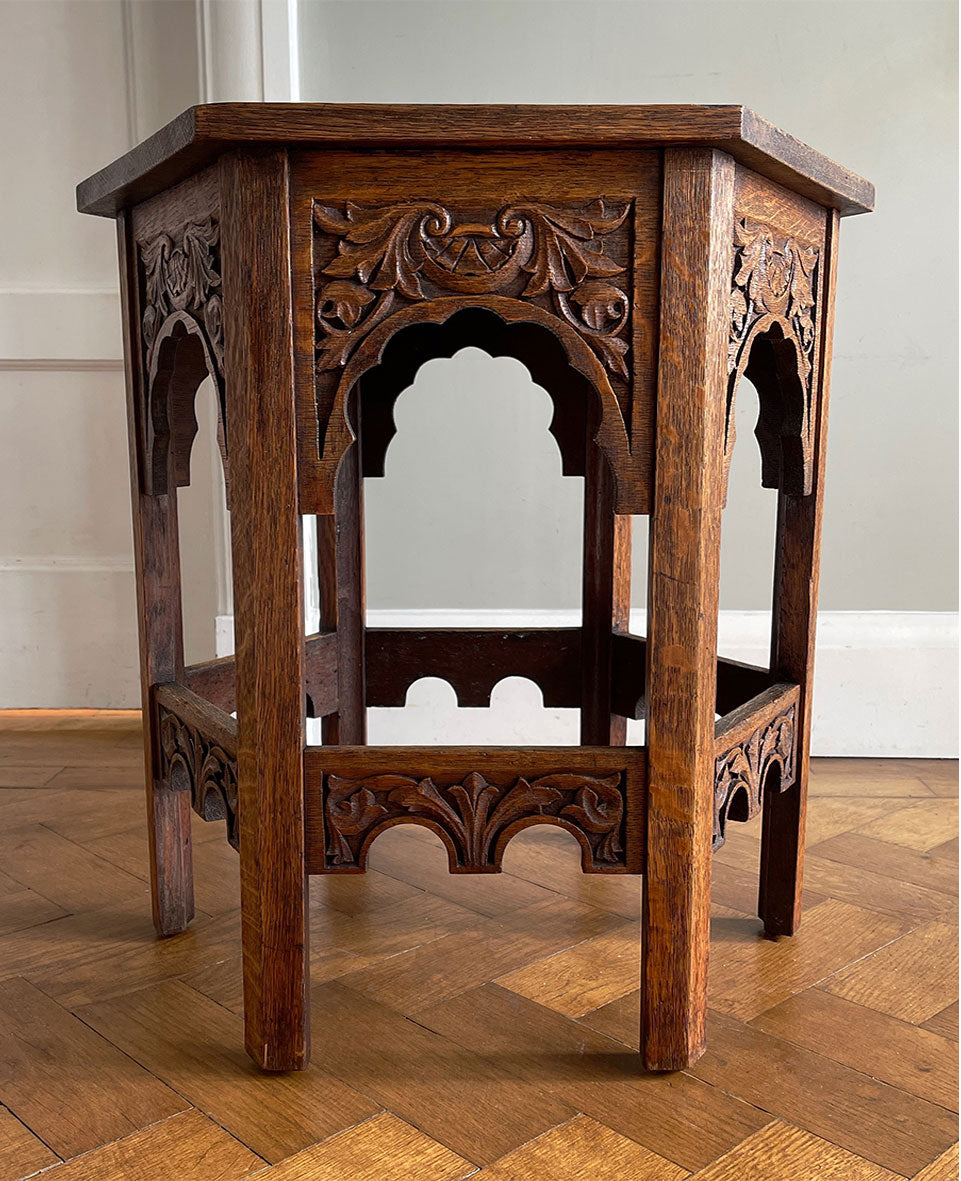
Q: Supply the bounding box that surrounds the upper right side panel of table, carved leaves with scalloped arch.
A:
[724,217,819,495]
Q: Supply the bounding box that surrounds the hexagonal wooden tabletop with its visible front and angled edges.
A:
[77,103,874,216]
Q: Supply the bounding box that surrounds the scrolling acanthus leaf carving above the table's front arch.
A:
[314,198,630,381]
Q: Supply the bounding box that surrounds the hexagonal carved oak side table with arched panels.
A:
[78,104,874,1070]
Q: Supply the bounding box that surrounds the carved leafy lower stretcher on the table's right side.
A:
[714,705,797,849]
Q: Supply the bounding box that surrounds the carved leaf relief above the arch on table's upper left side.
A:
[140,217,223,374]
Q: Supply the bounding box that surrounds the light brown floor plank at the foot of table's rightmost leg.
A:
[707,899,908,1020]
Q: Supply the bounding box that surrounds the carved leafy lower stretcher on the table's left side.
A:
[157,705,240,849]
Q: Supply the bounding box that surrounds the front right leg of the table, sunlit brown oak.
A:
[641,149,734,1070]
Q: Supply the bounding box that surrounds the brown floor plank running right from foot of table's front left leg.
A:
[312,980,575,1164]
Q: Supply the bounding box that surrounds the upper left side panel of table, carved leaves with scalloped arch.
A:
[139,216,227,494]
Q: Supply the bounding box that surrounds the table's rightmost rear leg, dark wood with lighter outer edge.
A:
[758,211,838,937]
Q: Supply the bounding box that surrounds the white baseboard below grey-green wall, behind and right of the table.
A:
[217,611,957,758]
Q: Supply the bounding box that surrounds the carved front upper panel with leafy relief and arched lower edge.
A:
[312,196,634,512]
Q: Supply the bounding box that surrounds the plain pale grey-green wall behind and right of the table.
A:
[301,0,957,611]
